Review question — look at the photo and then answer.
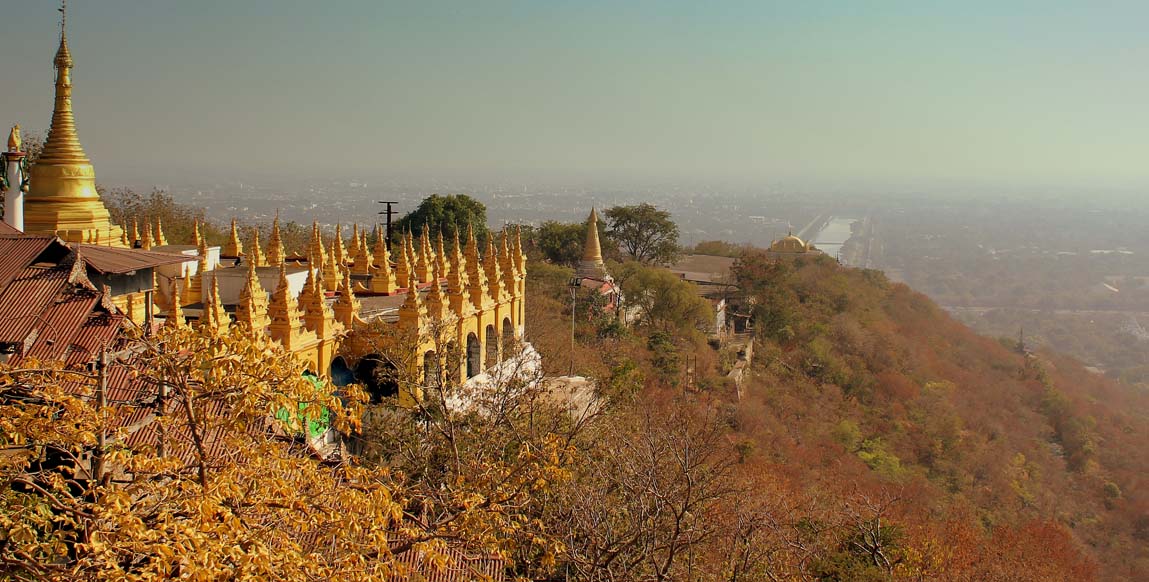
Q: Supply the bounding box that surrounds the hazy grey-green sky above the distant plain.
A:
[0,0,1149,187]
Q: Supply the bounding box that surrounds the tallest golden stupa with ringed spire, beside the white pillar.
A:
[24,17,123,246]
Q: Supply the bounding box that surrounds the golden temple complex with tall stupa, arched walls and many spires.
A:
[0,10,528,404]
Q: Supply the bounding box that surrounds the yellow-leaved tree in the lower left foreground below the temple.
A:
[0,329,552,581]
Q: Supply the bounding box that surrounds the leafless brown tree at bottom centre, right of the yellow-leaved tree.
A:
[549,404,737,581]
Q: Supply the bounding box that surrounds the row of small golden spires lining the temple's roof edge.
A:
[163,216,525,342]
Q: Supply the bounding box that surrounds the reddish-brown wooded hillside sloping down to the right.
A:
[532,254,1149,580]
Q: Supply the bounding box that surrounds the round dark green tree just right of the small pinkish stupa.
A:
[606,202,679,263]
